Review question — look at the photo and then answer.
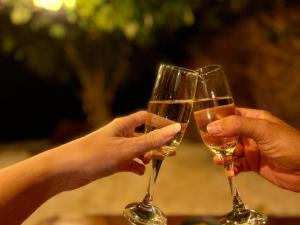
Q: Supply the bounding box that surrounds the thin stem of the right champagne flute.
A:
[223,157,248,215]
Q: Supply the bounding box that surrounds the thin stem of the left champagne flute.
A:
[139,159,163,211]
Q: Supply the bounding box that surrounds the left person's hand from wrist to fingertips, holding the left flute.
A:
[49,111,181,189]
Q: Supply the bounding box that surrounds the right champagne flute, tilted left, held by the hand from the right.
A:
[193,65,267,225]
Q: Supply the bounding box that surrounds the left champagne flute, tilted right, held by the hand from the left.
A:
[123,64,198,225]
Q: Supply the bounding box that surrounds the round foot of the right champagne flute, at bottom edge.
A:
[220,209,268,225]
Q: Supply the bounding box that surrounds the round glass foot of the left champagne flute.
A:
[123,203,167,225]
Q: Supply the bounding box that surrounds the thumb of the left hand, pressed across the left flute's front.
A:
[132,123,181,155]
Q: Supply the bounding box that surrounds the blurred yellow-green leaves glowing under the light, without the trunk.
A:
[0,0,201,79]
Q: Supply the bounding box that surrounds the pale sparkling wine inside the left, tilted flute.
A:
[145,100,194,156]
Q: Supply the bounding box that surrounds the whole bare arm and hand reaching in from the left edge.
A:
[0,111,181,225]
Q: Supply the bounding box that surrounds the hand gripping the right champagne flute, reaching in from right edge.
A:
[207,108,300,192]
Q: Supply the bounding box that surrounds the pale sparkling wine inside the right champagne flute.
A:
[194,97,238,157]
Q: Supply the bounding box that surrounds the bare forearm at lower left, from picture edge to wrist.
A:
[0,149,65,225]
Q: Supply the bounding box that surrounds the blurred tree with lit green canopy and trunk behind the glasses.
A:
[0,0,296,128]
